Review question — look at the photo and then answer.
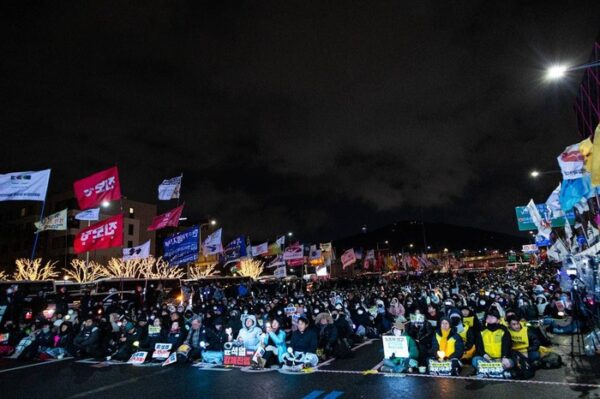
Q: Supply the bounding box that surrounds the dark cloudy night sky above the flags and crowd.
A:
[0,0,600,244]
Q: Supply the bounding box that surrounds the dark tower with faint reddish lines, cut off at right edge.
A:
[574,34,600,138]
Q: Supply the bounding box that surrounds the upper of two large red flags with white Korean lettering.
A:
[73,166,121,210]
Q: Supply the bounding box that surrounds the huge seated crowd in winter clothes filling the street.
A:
[0,266,584,378]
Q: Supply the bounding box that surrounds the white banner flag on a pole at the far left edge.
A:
[0,169,50,201]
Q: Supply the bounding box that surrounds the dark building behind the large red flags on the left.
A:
[0,192,156,270]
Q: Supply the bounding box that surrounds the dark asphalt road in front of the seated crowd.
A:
[0,341,600,399]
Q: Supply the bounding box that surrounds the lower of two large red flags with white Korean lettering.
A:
[73,215,123,254]
